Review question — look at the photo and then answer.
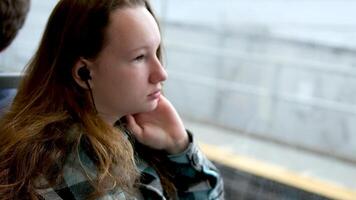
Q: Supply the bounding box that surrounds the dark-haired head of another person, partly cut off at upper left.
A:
[0,0,30,52]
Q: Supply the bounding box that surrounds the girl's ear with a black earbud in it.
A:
[72,58,91,89]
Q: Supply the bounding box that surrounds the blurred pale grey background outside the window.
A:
[0,0,356,199]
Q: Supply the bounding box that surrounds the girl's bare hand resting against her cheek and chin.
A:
[126,95,189,154]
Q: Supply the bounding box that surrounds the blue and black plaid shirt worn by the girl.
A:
[38,126,224,200]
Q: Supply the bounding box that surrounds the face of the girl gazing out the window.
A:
[88,7,167,124]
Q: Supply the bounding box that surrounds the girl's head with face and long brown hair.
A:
[0,0,166,198]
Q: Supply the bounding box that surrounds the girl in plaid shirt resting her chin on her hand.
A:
[0,0,223,200]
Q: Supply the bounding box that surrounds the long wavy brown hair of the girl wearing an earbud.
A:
[0,0,167,199]
